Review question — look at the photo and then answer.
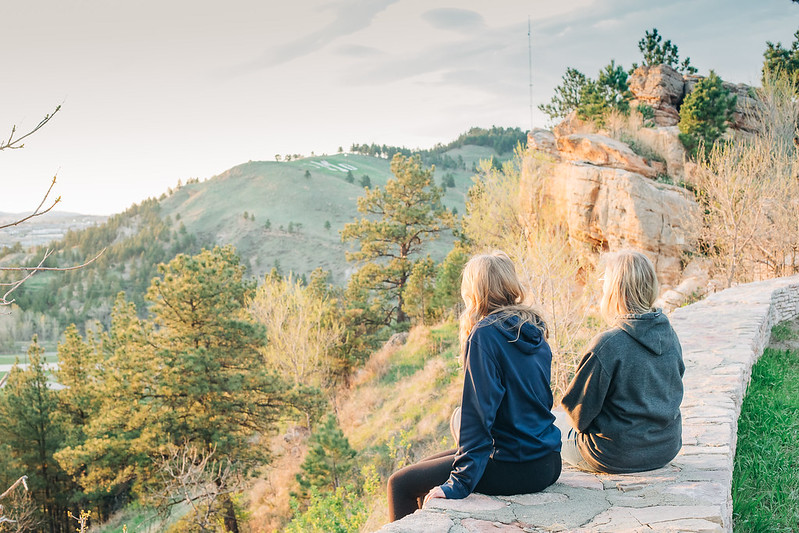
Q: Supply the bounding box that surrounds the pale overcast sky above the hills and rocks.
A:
[0,0,799,214]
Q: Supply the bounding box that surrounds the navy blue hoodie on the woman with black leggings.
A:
[441,315,560,499]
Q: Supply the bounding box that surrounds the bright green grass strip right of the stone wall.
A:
[732,321,799,531]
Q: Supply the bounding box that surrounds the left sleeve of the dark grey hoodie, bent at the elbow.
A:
[561,342,610,432]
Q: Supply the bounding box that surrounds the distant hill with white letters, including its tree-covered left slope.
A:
[0,138,512,332]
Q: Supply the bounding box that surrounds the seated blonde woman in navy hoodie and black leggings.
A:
[388,252,561,521]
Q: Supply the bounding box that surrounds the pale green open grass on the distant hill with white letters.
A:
[161,146,510,283]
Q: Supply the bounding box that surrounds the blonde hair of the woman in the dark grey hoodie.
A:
[600,250,658,325]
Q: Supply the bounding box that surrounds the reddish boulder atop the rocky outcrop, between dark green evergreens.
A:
[627,65,685,126]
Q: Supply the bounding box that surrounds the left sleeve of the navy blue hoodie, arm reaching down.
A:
[441,328,505,499]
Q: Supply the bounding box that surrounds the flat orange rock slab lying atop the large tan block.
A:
[557,133,662,178]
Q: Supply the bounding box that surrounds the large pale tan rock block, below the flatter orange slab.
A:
[544,161,700,287]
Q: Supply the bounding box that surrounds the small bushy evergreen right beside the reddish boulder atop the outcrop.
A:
[678,70,737,156]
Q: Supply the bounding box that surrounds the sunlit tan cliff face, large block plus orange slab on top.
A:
[523,126,700,288]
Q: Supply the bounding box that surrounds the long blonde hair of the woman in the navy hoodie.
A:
[459,251,547,361]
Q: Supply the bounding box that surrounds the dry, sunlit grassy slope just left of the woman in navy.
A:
[337,321,463,531]
